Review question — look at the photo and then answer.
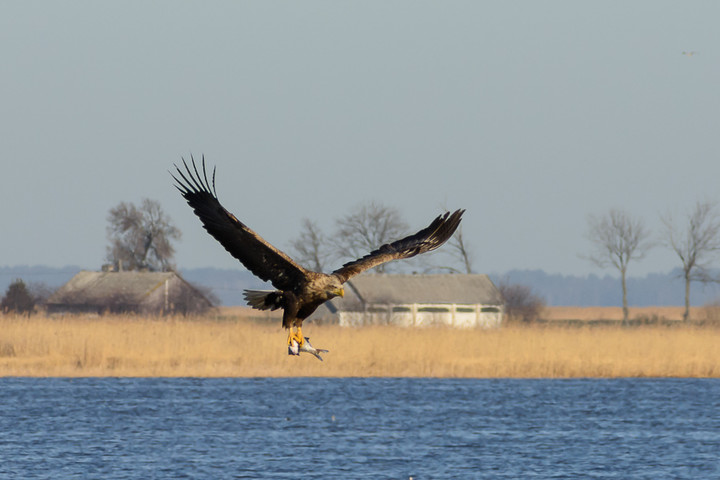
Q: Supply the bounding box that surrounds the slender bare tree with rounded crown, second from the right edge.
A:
[588,209,653,325]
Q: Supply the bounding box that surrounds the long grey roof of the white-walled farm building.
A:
[333,274,502,308]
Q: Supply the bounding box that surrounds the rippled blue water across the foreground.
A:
[0,378,720,480]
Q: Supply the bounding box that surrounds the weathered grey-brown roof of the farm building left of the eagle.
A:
[47,270,180,305]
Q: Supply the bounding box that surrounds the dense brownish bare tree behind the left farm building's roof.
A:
[107,198,180,270]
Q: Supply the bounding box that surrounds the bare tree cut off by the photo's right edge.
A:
[661,201,720,322]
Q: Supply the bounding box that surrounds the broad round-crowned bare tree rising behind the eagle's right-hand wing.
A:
[332,202,408,273]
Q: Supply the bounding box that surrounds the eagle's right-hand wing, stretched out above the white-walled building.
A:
[333,210,465,282]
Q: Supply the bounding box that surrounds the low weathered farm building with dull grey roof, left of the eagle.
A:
[46,271,212,315]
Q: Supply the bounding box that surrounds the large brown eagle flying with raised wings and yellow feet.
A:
[172,156,465,356]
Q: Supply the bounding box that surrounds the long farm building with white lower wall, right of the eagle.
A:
[310,274,503,328]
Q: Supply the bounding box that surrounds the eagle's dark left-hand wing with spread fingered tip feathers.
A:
[171,156,307,290]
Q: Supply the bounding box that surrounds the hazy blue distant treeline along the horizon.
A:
[0,265,720,307]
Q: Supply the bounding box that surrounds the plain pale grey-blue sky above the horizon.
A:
[0,0,720,275]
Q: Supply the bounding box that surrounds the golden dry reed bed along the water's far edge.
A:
[0,316,720,378]
